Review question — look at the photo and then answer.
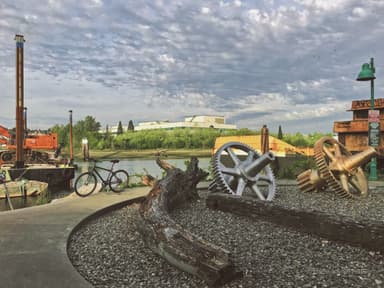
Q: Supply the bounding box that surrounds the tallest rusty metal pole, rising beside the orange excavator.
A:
[15,35,25,168]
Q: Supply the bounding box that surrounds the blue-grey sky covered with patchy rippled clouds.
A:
[0,0,384,133]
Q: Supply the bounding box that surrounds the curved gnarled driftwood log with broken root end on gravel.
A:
[137,158,241,286]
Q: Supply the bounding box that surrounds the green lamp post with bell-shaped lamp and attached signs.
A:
[356,58,380,180]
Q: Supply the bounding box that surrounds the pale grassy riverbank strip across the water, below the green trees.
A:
[70,149,212,159]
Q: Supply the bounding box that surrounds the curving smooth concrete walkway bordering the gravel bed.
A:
[0,187,150,288]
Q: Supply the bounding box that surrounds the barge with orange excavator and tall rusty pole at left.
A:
[0,34,75,188]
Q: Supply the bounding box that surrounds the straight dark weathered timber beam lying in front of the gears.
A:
[206,193,384,252]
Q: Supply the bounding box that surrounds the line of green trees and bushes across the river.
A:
[50,116,330,150]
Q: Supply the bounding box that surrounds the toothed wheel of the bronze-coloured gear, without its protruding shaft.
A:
[314,137,368,197]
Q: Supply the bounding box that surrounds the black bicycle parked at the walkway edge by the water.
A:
[74,159,129,197]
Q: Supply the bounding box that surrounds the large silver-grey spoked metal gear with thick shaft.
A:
[209,142,276,201]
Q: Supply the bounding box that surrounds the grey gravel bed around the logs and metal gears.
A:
[68,186,384,288]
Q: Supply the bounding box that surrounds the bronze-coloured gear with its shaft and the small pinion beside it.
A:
[297,137,377,198]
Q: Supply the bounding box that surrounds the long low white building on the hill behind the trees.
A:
[135,116,236,131]
